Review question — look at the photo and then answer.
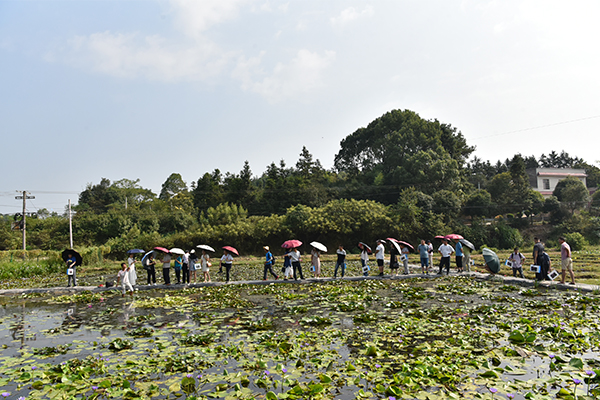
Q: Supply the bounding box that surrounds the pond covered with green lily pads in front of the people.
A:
[0,277,600,399]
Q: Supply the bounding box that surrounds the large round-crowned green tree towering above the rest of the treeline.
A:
[334,110,473,204]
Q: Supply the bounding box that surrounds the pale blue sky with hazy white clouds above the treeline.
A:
[0,0,600,213]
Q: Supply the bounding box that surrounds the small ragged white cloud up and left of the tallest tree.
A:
[233,49,335,102]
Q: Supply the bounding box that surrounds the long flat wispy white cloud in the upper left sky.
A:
[63,32,227,81]
